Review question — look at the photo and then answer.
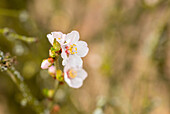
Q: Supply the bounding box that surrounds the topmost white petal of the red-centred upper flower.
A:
[66,31,79,45]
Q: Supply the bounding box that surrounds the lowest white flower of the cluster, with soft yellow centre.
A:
[64,56,87,88]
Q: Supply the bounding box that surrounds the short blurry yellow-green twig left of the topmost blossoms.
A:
[0,28,37,43]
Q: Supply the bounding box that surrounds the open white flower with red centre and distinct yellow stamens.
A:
[61,31,89,65]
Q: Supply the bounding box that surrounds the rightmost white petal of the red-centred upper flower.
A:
[77,41,89,57]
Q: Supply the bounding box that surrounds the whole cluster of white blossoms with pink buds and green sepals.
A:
[41,31,89,88]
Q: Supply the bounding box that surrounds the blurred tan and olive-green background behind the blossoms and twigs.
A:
[0,0,170,114]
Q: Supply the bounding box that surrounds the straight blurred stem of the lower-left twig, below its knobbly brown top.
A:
[7,67,44,114]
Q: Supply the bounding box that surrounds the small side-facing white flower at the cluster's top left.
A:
[47,32,66,45]
